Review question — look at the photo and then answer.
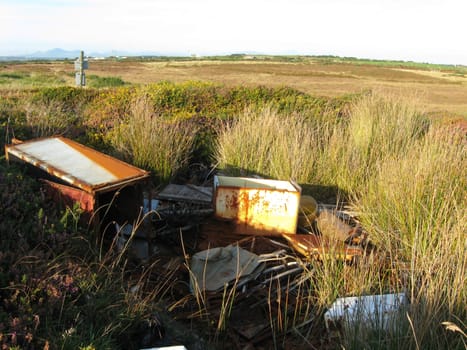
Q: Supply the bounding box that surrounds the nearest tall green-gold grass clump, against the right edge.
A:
[344,129,467,349]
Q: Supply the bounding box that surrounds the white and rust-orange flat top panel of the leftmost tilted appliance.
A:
[5,137,149,193]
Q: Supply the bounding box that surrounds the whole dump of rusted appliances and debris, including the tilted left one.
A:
[5,137,407,349]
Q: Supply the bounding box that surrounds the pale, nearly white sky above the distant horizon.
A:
[0,0,467,65]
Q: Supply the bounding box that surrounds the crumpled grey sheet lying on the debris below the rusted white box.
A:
[190,245,264,293]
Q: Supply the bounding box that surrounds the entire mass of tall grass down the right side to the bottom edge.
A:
[315,94,467,349]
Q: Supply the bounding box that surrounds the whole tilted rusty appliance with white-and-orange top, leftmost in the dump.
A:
[5,137,149,228]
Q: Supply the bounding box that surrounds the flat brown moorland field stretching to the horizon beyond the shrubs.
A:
[0,59,467,117]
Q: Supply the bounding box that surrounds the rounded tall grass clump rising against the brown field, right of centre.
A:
[317,92,429,193]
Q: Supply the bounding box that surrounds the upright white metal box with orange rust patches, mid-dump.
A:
[213,176,301,235]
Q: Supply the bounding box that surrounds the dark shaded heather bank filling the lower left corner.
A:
[0,159,163,349]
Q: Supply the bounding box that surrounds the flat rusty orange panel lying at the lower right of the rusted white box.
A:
[282,234,363,261]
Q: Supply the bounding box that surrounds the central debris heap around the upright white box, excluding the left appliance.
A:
[115,176,382,348]
